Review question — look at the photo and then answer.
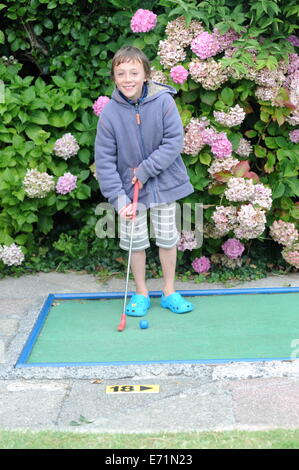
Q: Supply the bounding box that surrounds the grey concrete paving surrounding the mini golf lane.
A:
[0,272,299,433]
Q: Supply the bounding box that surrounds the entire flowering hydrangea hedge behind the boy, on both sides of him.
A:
[0,0,299,275]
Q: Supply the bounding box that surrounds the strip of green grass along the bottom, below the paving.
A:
[0,429,299,449]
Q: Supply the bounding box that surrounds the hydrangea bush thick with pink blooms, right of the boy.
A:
[135,4,299,273]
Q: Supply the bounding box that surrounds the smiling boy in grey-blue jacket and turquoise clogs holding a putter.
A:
[95,46,194,316]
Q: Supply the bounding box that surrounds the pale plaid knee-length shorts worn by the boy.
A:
[119,202,180,251]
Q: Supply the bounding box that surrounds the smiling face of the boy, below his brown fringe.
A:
[114,60,146,101]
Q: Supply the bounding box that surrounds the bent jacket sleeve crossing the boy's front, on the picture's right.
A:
[135,93,184,184]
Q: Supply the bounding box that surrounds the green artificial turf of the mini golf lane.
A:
[27,293,299,364]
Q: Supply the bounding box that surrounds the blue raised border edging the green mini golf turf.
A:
[15,287,299,368]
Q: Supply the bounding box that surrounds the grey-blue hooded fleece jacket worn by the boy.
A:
[95,80,194,211]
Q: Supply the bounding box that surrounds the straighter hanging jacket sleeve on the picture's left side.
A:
[95,117,131,211]
